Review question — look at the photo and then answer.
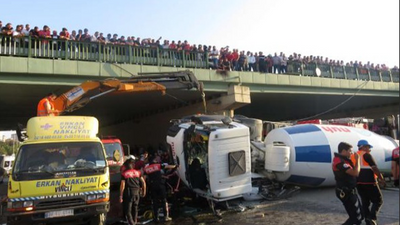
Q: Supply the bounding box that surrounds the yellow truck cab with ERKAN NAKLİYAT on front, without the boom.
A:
[6,116,110,225]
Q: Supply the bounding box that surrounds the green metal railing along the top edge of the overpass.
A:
[0,34,399,83]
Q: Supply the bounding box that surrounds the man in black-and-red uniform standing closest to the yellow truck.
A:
[119,159,146,225]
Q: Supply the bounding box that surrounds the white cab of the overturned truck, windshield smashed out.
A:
[167,115,252,202]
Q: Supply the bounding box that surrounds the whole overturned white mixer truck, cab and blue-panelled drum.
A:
[167,115,398,204]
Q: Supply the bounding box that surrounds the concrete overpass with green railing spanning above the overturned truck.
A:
[0,36,399,146]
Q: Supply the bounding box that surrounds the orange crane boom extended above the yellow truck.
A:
[52,70,203,115]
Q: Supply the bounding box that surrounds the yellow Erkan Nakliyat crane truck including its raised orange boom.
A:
[6,70,204,225]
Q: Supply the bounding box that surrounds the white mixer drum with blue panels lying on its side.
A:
[264,124,398,187]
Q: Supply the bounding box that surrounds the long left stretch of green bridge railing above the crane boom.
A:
[0,35,209,69]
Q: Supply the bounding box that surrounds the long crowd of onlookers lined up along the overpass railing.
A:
[0,21,399,74]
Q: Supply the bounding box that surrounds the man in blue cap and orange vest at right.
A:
[357,140,385,225]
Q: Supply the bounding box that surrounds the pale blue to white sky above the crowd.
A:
[0,0,399,67]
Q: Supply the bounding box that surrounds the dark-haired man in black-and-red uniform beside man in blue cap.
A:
[332,142,364,225]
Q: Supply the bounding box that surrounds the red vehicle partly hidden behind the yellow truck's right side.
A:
[101,136,125,184]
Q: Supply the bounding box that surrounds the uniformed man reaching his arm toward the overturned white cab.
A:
[144,155,177,222]
